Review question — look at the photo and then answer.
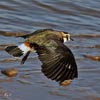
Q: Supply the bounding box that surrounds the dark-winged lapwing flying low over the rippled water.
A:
[5,29,78,84]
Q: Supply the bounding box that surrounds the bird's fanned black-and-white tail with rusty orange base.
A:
[5,42,33,63]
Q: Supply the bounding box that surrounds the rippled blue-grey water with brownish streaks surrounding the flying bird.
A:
[0,0,100,100]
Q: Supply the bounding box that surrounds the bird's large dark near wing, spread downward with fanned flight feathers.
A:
[35,42,78,82]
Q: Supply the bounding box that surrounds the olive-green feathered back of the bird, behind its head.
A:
[26,32,62,46]
